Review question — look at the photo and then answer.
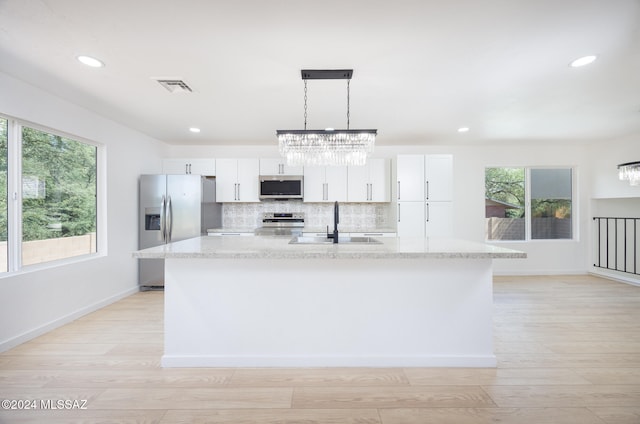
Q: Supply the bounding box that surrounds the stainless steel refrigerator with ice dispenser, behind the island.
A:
[138,175,220,290]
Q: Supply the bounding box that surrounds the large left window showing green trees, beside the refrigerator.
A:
[0,119,98,272]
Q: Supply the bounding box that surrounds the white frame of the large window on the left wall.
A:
[0,113,107,279]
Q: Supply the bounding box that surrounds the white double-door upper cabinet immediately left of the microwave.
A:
[216,159,260,203]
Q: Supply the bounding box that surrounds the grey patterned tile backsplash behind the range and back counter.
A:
[222,201,392,231]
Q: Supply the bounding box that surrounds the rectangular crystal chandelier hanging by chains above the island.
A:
[276,69,377,166]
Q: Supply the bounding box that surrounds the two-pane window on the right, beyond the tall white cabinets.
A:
[485,168,573,240]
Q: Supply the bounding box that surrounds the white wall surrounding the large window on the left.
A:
[0,73,165,351]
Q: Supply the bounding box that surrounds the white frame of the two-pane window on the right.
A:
[484,165,579,243]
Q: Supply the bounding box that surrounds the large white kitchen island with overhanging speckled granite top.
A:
[134,236,526,367]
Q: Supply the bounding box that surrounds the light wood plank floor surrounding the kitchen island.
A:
[0,276,640,424]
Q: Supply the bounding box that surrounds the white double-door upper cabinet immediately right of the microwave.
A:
[304,166,347,202]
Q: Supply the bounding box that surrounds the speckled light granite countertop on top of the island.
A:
[133,236,527,259]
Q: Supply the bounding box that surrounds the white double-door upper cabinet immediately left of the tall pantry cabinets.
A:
[347,159,391,202]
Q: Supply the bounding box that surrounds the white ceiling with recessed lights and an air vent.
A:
[0,0,640,145]
